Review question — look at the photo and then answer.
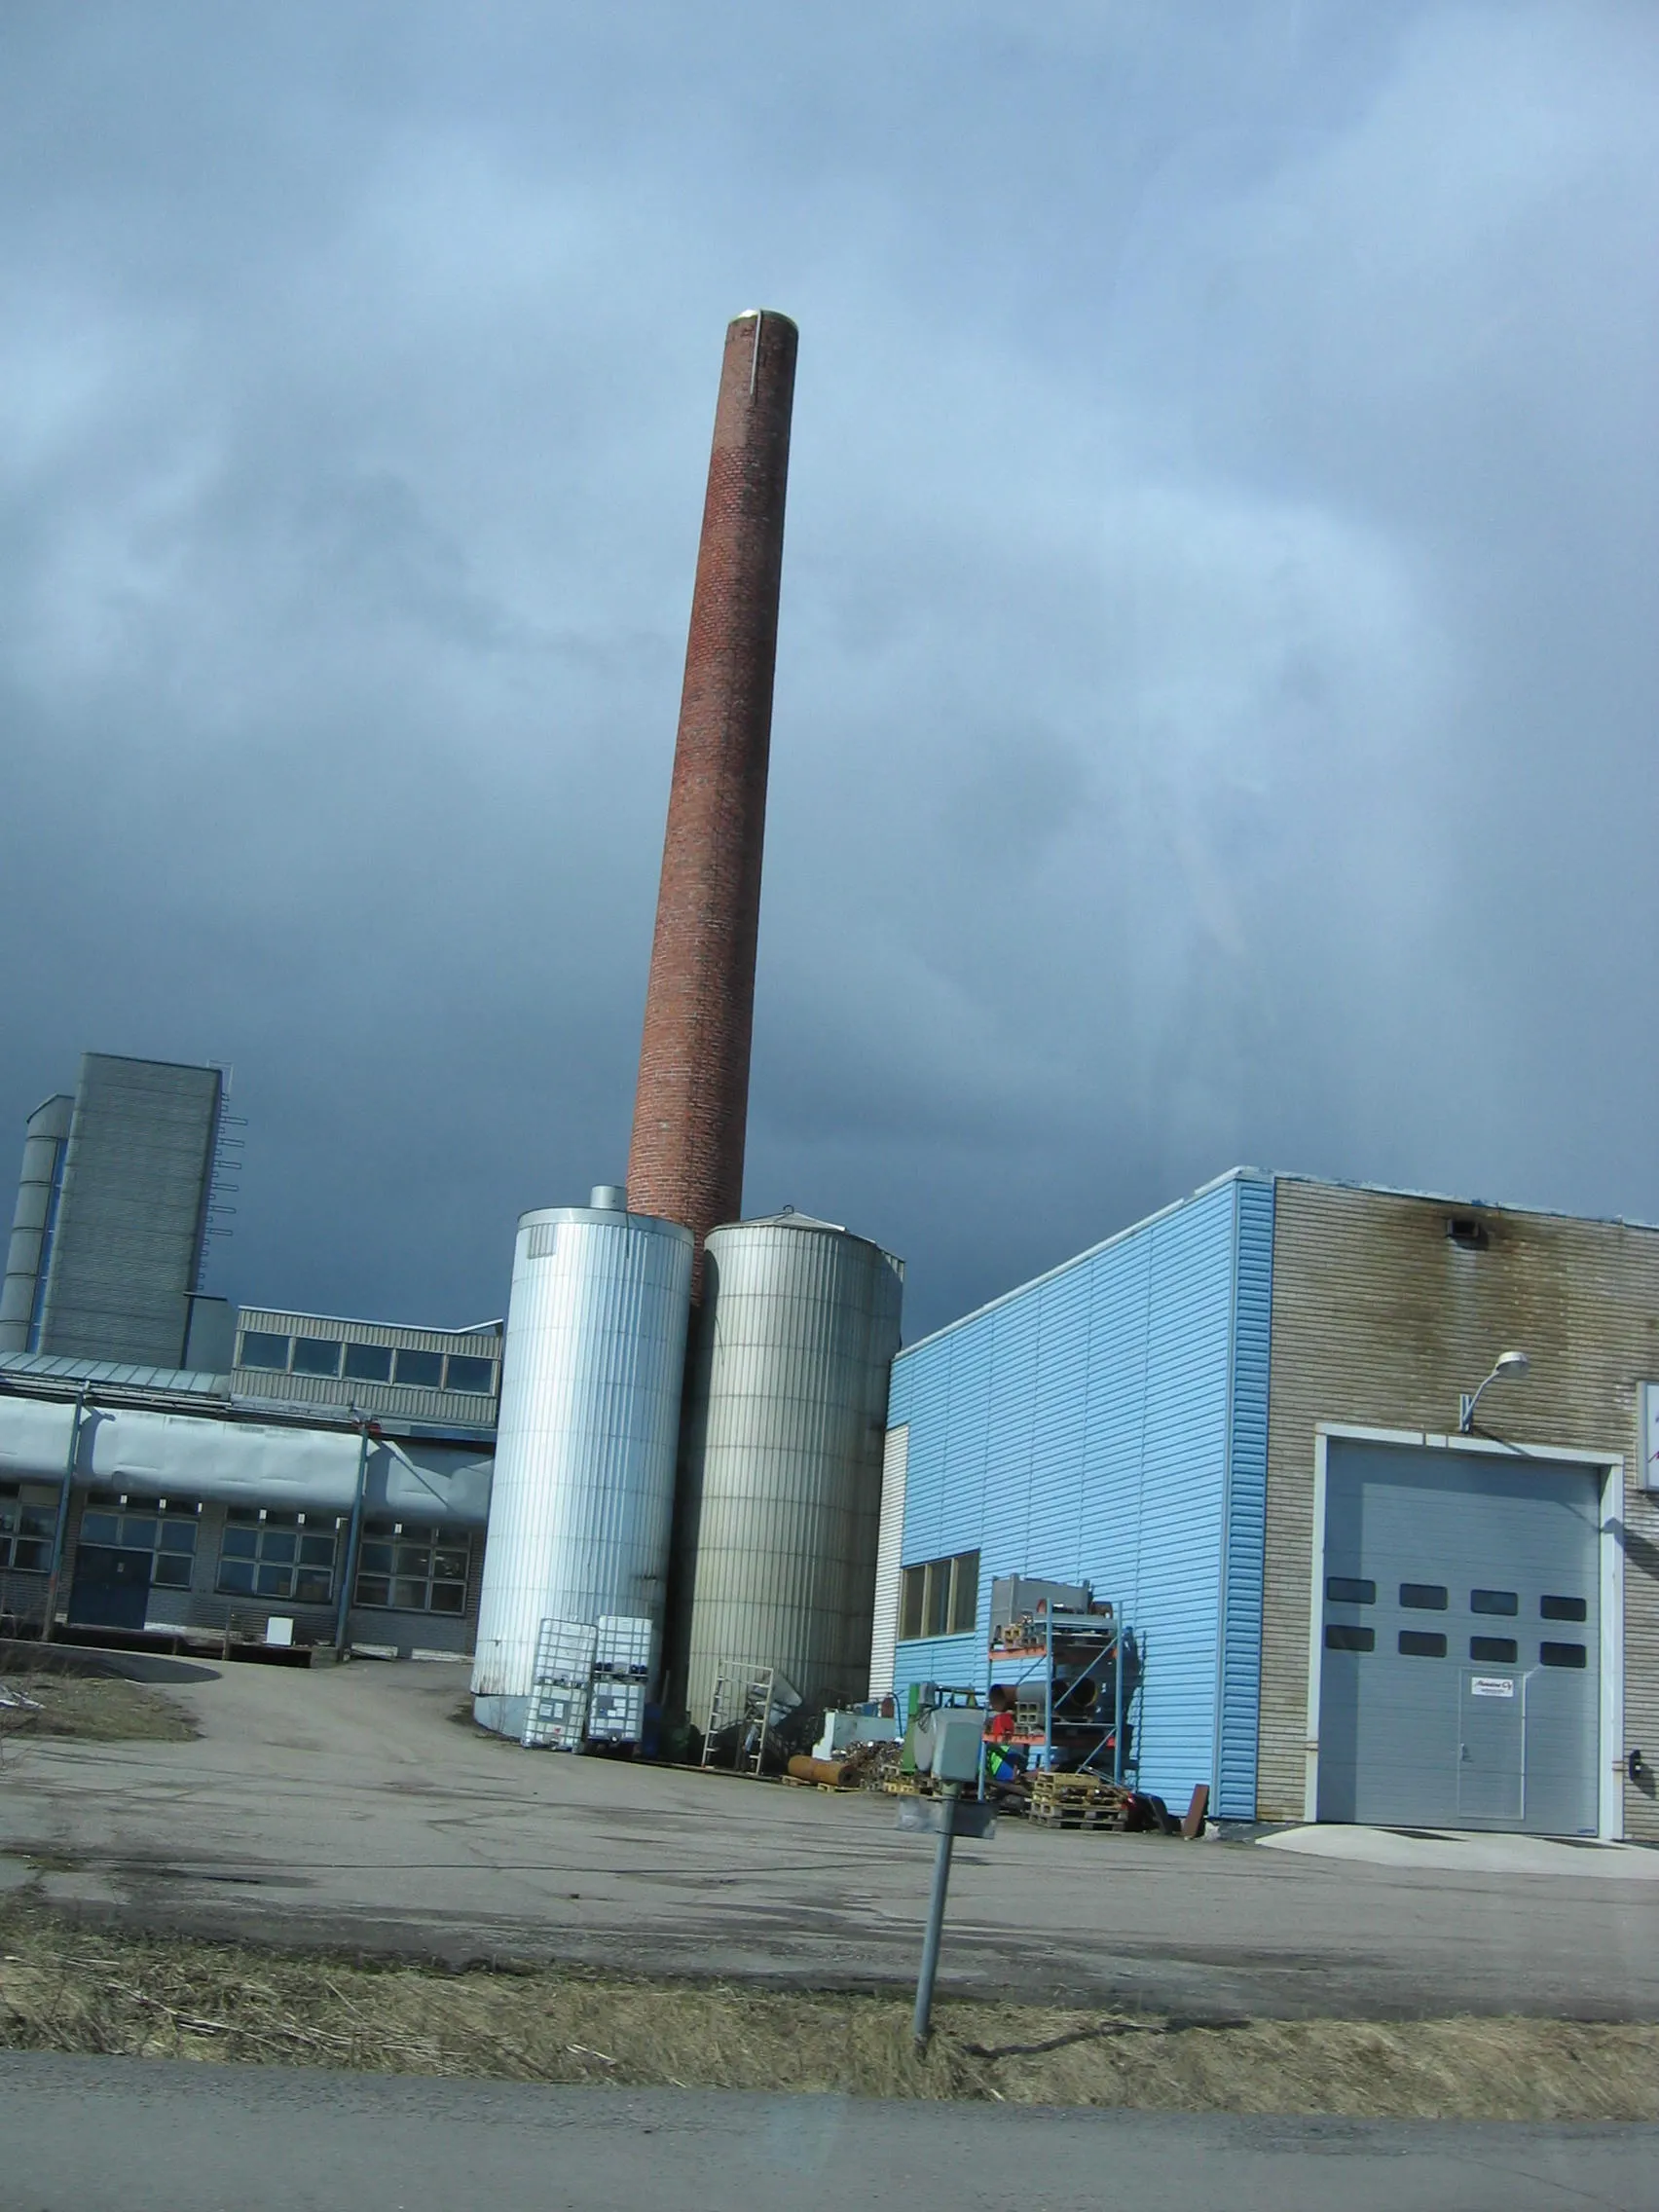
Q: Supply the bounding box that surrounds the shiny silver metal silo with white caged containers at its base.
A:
[473,1184,692,1737]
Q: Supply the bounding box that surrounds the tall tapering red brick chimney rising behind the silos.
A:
[628,310,798,1294]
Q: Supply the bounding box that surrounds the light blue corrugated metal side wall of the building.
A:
[887,1177,1272,1819]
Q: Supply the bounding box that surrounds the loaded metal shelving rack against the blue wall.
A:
[984,1605,1141,1786]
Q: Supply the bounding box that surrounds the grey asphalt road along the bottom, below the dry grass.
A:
[0,2052,1659,2212]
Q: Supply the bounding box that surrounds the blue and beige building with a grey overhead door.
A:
[869,1168,1659,1840]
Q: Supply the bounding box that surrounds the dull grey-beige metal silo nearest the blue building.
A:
[670,1212,904,1727]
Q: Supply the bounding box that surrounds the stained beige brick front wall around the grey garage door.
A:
[1259,1179,1659,1840]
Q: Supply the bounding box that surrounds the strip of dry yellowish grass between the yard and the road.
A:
[0,1902,1659,2120]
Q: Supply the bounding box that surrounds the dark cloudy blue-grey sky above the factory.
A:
[0,0,1659,1339]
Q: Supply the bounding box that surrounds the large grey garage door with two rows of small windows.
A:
[1318,1438,1602,1836]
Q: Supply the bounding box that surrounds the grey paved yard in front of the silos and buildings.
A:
[0,1661,1659,2019]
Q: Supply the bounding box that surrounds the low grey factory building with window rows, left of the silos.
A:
[0,1309,499,1659]
